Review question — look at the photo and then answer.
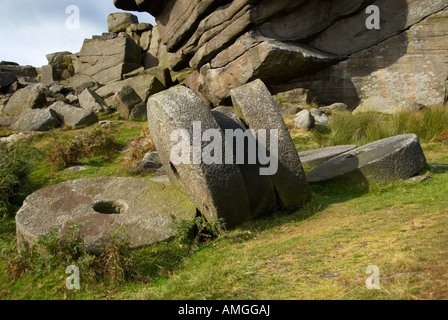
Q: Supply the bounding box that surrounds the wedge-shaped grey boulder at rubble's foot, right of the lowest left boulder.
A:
[50,101,98,128]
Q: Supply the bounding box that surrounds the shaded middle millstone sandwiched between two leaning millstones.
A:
[212,107,277,218]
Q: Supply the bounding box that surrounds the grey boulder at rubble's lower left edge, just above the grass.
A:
[10,109,60,131]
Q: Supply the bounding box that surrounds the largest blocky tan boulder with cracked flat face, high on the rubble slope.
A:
[73,36,141,84]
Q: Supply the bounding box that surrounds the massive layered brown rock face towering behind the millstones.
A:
[114,0,448,109]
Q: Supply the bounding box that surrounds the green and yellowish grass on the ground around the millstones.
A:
[0,110,448,300]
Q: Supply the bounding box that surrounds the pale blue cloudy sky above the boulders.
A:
[0,0,155,67]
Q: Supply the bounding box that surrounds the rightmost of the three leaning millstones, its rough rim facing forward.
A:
[230,80,311,211]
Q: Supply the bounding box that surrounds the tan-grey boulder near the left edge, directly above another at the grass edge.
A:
[3,84,47,116]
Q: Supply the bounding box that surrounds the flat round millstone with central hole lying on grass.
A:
[16,177,196,251]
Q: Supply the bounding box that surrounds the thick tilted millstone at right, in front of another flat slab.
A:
[307,134,426,183]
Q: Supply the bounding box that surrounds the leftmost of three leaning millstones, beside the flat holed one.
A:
[147,86,250,226]
